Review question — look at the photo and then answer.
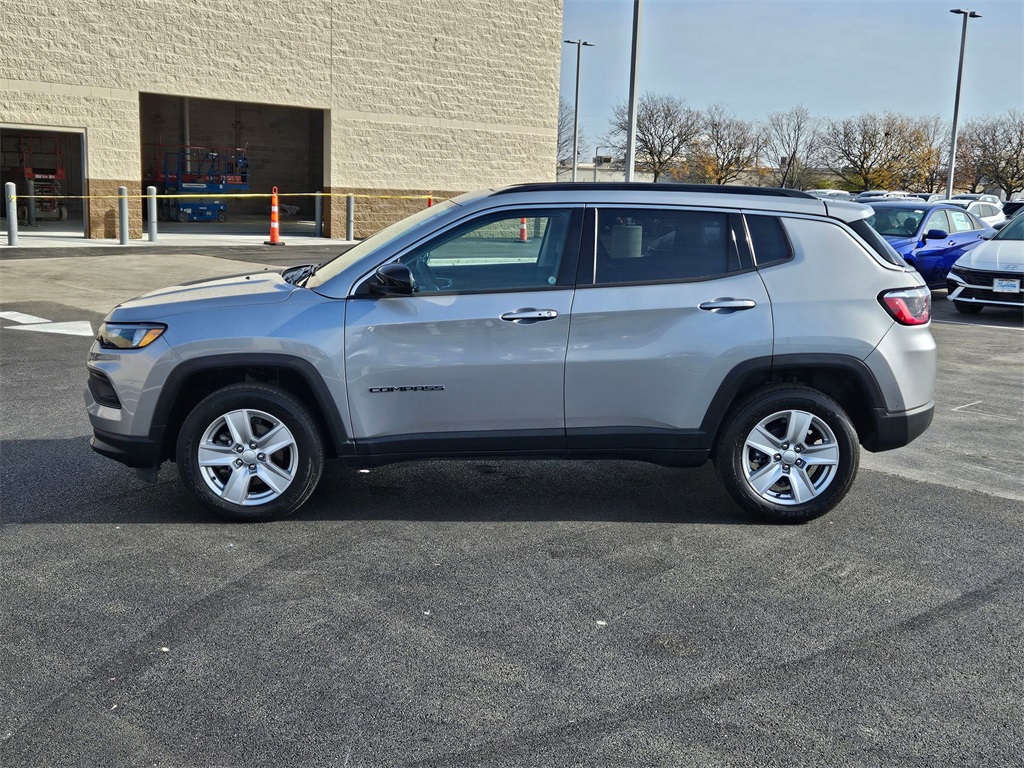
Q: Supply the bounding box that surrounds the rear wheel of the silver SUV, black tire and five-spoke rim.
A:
[714,384,860,523]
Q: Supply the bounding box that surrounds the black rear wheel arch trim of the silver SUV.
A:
[700,354,885,446]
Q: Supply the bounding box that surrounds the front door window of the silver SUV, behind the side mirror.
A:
[399,209,573,293]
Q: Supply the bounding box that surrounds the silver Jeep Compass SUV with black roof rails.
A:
[85,183,936,522]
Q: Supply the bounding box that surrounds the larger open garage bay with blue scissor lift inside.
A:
[139,93,325,237]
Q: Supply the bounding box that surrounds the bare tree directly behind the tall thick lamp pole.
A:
[601,93,701,181]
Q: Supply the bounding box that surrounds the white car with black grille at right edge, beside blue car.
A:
[946,208,1024,314]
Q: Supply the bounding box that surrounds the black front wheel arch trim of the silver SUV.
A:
[151,353,350,460]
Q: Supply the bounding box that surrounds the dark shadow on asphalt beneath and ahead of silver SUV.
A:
[0,437,758,525]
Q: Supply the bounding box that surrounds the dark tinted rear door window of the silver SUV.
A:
[592,208,742,285]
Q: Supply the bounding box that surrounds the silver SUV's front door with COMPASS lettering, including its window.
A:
[345,208,582,455]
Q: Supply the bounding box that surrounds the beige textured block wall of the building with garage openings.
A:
[0,0,561,237]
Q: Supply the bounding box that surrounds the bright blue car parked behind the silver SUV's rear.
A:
[867,200,995,288]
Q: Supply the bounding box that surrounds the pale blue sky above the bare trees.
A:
[560,0,1024,154]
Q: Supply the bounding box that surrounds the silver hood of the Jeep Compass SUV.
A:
[110,270,303,323]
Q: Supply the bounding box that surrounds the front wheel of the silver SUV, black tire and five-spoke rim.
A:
[175,383,324,521]
